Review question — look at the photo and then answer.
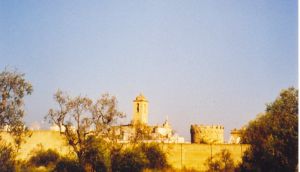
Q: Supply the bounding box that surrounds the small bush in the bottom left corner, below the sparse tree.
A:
[0,142,16,172]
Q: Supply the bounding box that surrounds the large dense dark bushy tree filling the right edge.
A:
[240,88,298,171]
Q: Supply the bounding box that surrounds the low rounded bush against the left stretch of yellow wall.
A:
[28,149,60,167]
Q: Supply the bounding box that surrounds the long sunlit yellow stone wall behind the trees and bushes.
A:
[1,130,248,171]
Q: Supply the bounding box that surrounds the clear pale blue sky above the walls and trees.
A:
[0,0,298,140]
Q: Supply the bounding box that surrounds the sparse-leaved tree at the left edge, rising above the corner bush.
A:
[0,69,33,146]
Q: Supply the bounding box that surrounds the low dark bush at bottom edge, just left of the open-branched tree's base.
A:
[53,158,84,172]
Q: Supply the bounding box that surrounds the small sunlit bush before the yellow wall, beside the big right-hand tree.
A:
[206,149,234,172]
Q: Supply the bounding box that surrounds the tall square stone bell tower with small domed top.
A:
[132,94,148,124]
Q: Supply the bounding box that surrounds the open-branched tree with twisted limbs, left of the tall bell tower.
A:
[46,90,124,169]
